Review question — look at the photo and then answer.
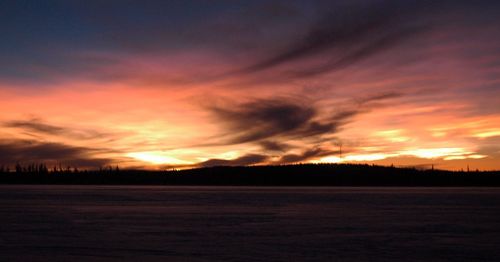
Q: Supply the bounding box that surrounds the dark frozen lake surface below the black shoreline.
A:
[0,186,500,261]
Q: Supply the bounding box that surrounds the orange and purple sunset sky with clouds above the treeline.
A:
[0,0,500,170]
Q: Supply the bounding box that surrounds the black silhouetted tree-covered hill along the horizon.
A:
[0,164,500,186]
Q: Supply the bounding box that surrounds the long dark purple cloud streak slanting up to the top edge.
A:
[236,1,429,77]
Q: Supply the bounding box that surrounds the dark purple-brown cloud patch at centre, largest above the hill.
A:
[209,93,400,145]
